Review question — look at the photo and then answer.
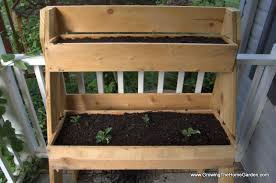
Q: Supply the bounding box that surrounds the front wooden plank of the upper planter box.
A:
[46,43,237,72]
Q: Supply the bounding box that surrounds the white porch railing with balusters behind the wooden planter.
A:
[0,40,276,182]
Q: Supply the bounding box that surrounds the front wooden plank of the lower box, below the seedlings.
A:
[48,145,234,170]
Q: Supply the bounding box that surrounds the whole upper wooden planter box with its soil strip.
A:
[40,6,239,72]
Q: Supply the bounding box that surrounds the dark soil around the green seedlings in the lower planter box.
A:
[55,112,230,146]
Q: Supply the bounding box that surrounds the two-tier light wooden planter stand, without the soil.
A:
[40,6,239,182]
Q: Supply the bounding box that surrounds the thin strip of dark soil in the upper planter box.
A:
[57,36,227,44]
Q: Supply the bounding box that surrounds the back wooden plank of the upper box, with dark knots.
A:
[57,5,225,33]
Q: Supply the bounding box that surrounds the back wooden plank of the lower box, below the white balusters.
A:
[65,93,212,111]
